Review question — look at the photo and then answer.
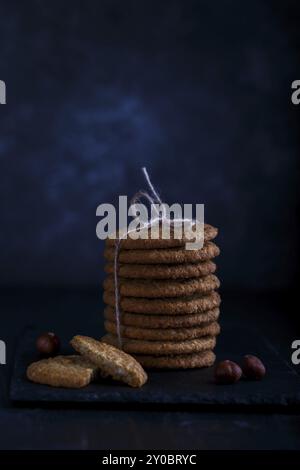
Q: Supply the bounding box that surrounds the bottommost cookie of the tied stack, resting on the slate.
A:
[134,351,216,369]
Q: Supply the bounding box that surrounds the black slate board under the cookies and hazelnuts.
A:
[10,328,300,407]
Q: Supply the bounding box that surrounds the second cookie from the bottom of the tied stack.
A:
[102,334,216,356]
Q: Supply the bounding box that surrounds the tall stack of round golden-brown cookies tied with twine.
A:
[102,224,220,369]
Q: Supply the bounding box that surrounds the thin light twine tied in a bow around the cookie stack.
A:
[114,167,198,349]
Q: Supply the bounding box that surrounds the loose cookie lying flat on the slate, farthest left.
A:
[26,355,97,388]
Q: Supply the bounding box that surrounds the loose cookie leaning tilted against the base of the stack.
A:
[71,335,148,387]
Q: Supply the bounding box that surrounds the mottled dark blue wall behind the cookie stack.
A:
[0,0,300,289]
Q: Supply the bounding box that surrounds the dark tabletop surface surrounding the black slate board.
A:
[0,288,300,450]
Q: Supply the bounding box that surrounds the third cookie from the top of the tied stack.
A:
[104,261,216,279]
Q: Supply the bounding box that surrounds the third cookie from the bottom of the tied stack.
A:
[104,321,220,341]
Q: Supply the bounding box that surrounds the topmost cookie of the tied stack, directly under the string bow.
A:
[105,224,218,250]
